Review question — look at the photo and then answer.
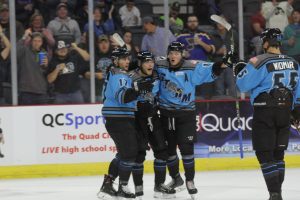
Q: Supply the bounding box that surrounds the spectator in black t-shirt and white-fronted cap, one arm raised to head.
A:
[47,40,89,104]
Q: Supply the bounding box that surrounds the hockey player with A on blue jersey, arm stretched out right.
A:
[156,42,233,198]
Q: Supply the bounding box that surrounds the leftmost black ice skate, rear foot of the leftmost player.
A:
[97,175,117,200]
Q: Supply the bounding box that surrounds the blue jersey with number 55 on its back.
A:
[237,53,300,104]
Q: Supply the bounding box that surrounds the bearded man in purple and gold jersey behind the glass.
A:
[177,15,215,61]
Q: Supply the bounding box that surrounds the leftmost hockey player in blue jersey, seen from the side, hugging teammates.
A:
[98,48,153,199]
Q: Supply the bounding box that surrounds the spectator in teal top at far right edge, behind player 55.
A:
[283,9,300,62]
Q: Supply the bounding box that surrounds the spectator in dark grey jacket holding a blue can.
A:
[17,32,49,105]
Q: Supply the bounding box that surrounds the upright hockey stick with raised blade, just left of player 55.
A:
[210,15,244,158]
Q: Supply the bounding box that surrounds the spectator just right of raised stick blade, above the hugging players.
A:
[123,29,139,71]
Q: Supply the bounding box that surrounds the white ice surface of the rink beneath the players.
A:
[0,169,300,200]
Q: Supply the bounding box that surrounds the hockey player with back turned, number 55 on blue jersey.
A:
[234,28,300,200]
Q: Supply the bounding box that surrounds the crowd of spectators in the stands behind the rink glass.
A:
[0,0,300,105]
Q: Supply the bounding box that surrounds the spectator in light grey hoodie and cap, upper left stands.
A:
[48,3,81,44]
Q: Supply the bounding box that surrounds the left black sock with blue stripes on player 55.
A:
[260,162,280,193]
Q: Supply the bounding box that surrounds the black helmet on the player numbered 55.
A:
[260,28,283,46]
